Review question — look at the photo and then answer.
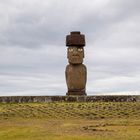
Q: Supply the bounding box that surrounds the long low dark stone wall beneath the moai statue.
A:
[0,95,140,103]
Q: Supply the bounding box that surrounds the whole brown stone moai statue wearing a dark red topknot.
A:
[65,31,87,95]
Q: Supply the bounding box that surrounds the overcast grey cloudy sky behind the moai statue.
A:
[0,0,140,96]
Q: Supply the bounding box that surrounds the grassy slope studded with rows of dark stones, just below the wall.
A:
[0,102,140,119]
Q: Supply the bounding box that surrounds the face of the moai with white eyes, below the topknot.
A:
[67,46,84,64]
